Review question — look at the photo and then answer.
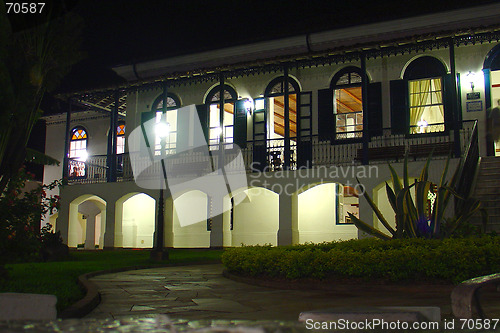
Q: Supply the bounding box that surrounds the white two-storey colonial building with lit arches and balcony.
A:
[44,4,500,248]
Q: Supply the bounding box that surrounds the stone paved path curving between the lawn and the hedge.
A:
[87,264,498,321]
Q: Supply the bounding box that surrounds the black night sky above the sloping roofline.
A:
[47,0,495,90]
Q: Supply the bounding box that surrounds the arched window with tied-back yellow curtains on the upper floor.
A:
[404,56,446,134]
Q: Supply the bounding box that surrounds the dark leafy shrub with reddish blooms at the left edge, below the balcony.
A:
[0,167,61,265]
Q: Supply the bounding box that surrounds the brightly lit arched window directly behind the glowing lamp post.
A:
[151,93,181,155]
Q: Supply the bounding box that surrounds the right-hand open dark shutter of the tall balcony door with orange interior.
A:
[297,91,312,167]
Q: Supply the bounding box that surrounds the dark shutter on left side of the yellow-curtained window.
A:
[390,80,410,134]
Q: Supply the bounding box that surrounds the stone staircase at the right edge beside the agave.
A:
[473,156,500,233]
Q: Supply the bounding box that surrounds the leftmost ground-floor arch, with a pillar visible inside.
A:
[68,194,106,249]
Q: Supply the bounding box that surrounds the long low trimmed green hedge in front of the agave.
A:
[222,236,500,283]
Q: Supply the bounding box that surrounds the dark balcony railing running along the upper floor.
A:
[68,121,475,184]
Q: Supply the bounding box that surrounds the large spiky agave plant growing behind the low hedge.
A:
[348,153,481,239]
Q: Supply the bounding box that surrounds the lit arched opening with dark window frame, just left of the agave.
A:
[292,183,358,244]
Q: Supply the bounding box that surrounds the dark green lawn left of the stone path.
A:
[0,249,223,312]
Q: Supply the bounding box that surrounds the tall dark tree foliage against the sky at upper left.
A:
[0,4,82,192]
